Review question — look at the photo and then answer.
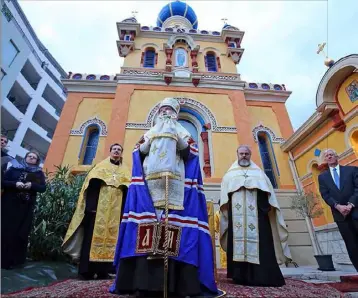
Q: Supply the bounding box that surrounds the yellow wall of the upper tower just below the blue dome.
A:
[123,37,237,73]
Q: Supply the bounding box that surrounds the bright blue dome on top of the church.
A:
[157,1,198,29]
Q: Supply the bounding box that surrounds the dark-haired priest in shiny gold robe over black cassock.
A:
[63,143,131,280]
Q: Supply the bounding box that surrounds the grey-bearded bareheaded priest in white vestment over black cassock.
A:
[220,145,291,287]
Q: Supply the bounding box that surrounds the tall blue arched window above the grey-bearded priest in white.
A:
[257,132,277,188]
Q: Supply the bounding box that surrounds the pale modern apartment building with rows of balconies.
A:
[1,0,67,161]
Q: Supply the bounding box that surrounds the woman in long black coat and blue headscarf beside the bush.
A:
[1,152,46,269]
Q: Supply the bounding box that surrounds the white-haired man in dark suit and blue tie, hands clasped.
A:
[318,149,358,271]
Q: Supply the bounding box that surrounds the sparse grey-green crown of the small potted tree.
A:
[291,192,323,218]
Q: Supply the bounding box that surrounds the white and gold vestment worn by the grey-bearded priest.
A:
[220,161,292,264]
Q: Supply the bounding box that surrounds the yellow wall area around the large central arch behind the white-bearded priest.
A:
[124,90,238,178]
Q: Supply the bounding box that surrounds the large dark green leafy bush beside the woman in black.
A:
[29,166,86,260]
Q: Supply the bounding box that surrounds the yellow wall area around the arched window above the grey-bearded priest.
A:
[248,106,294,186]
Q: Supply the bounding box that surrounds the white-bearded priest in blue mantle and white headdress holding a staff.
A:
[110,98,218,297]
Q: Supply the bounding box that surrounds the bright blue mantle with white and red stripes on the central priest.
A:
[110,144,218,294]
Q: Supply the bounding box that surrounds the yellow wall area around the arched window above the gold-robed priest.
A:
[62,98,113,168]
